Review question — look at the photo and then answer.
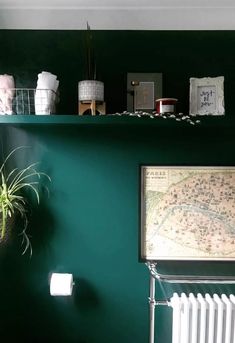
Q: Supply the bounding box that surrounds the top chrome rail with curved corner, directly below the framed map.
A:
[146,262,235,284]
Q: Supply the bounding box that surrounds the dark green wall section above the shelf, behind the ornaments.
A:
[0,30,235,114]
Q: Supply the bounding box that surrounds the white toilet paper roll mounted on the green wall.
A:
[50,273,73,296]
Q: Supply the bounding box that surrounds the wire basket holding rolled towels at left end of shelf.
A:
[0,88,58,115]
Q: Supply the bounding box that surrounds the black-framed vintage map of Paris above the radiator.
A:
[140,166,235,261]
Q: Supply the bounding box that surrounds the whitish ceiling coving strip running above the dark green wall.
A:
[0,6,235,30]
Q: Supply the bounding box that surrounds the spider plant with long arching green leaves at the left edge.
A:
[0,146,50,255]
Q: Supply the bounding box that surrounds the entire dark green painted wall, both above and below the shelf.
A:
[0,31,235,343]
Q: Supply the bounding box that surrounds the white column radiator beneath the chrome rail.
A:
[170,293,235,343]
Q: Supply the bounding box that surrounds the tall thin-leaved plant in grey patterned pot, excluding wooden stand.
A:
[78,23,104,107]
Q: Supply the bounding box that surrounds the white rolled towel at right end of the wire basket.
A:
[35,71,59,114]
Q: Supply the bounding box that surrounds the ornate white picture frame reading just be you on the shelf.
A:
[189,76,224,115]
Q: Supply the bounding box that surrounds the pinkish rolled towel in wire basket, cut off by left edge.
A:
[0,74,15,114]
